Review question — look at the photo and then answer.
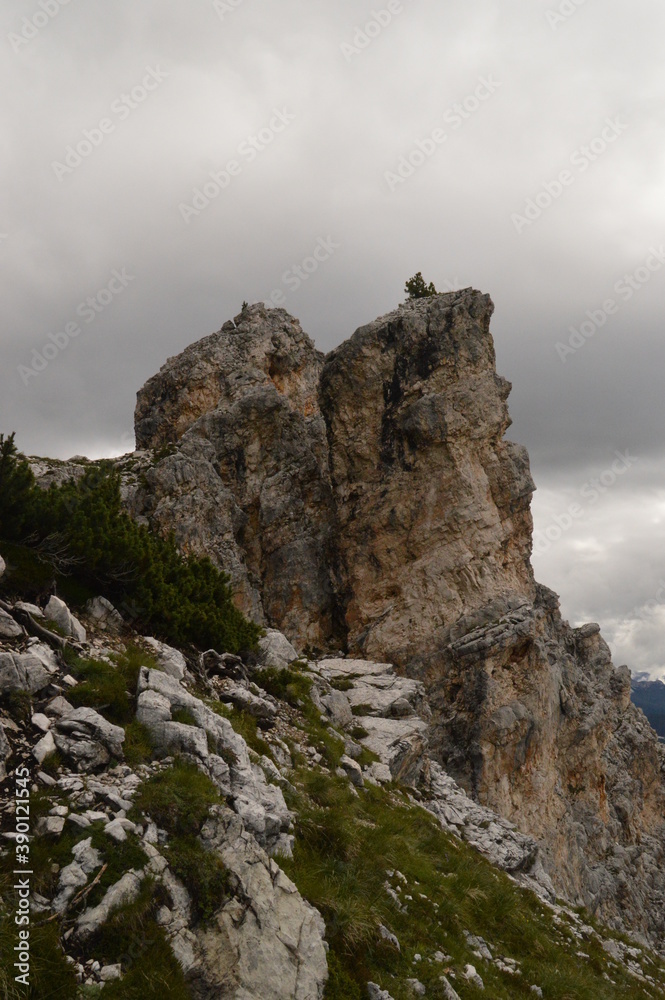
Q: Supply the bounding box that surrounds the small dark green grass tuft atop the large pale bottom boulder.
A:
[164,836,230,924]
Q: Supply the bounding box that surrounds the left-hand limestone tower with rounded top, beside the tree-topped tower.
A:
[130,305,335,645]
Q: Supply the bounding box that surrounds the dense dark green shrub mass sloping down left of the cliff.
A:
[0,435,260,653]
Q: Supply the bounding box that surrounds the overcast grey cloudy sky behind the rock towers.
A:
[0,0,665,675]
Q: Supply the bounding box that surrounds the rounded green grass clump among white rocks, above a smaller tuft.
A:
[130,760,223,837]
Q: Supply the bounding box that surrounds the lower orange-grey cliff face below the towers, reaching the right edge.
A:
[428,586,665,940]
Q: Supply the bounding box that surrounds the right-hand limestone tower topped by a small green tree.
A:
[321,289,534,665]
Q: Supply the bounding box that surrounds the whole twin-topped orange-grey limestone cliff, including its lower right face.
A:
[124,289,665,944]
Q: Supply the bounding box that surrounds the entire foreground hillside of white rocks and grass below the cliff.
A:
[0,572,665,1000]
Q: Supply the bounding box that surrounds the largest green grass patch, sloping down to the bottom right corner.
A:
[280,768,662,1000]
